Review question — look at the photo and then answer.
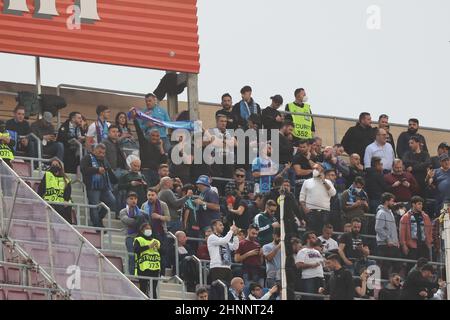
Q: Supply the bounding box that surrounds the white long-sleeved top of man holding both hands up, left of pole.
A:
[207,230,239,269]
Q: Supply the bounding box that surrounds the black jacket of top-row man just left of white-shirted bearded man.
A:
[341,122,375,159]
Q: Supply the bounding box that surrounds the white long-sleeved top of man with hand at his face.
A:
[300,178,336,211]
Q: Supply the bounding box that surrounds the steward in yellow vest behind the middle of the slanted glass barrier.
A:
[38,159,74,224]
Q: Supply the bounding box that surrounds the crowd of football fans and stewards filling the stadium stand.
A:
[0,86,450,300]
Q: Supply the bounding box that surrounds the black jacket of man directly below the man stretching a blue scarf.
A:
[134,120,167,171]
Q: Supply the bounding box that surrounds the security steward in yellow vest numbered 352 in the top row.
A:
[285,88,316,140]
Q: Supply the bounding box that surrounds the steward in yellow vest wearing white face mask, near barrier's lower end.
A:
[134,223,161,299]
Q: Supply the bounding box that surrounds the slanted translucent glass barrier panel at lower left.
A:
[0,161,145,300]
